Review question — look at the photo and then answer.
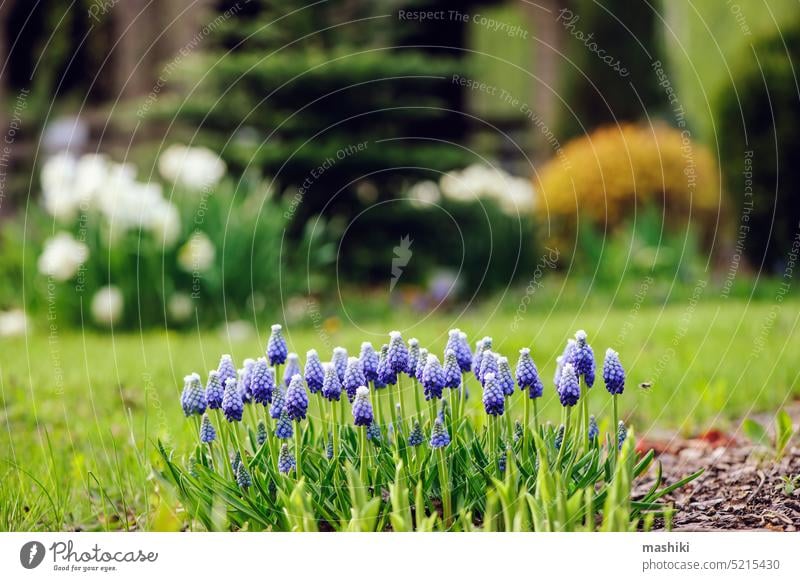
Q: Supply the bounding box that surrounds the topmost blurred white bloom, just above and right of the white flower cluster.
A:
[158,144,227,191]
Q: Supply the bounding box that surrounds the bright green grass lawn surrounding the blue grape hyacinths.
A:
[0,299,800,530]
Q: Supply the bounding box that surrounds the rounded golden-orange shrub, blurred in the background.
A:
[534,124,721,236]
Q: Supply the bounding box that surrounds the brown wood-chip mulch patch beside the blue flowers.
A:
[636,405,800,531]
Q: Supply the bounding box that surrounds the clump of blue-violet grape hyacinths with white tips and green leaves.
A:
[170,326,696,530]
